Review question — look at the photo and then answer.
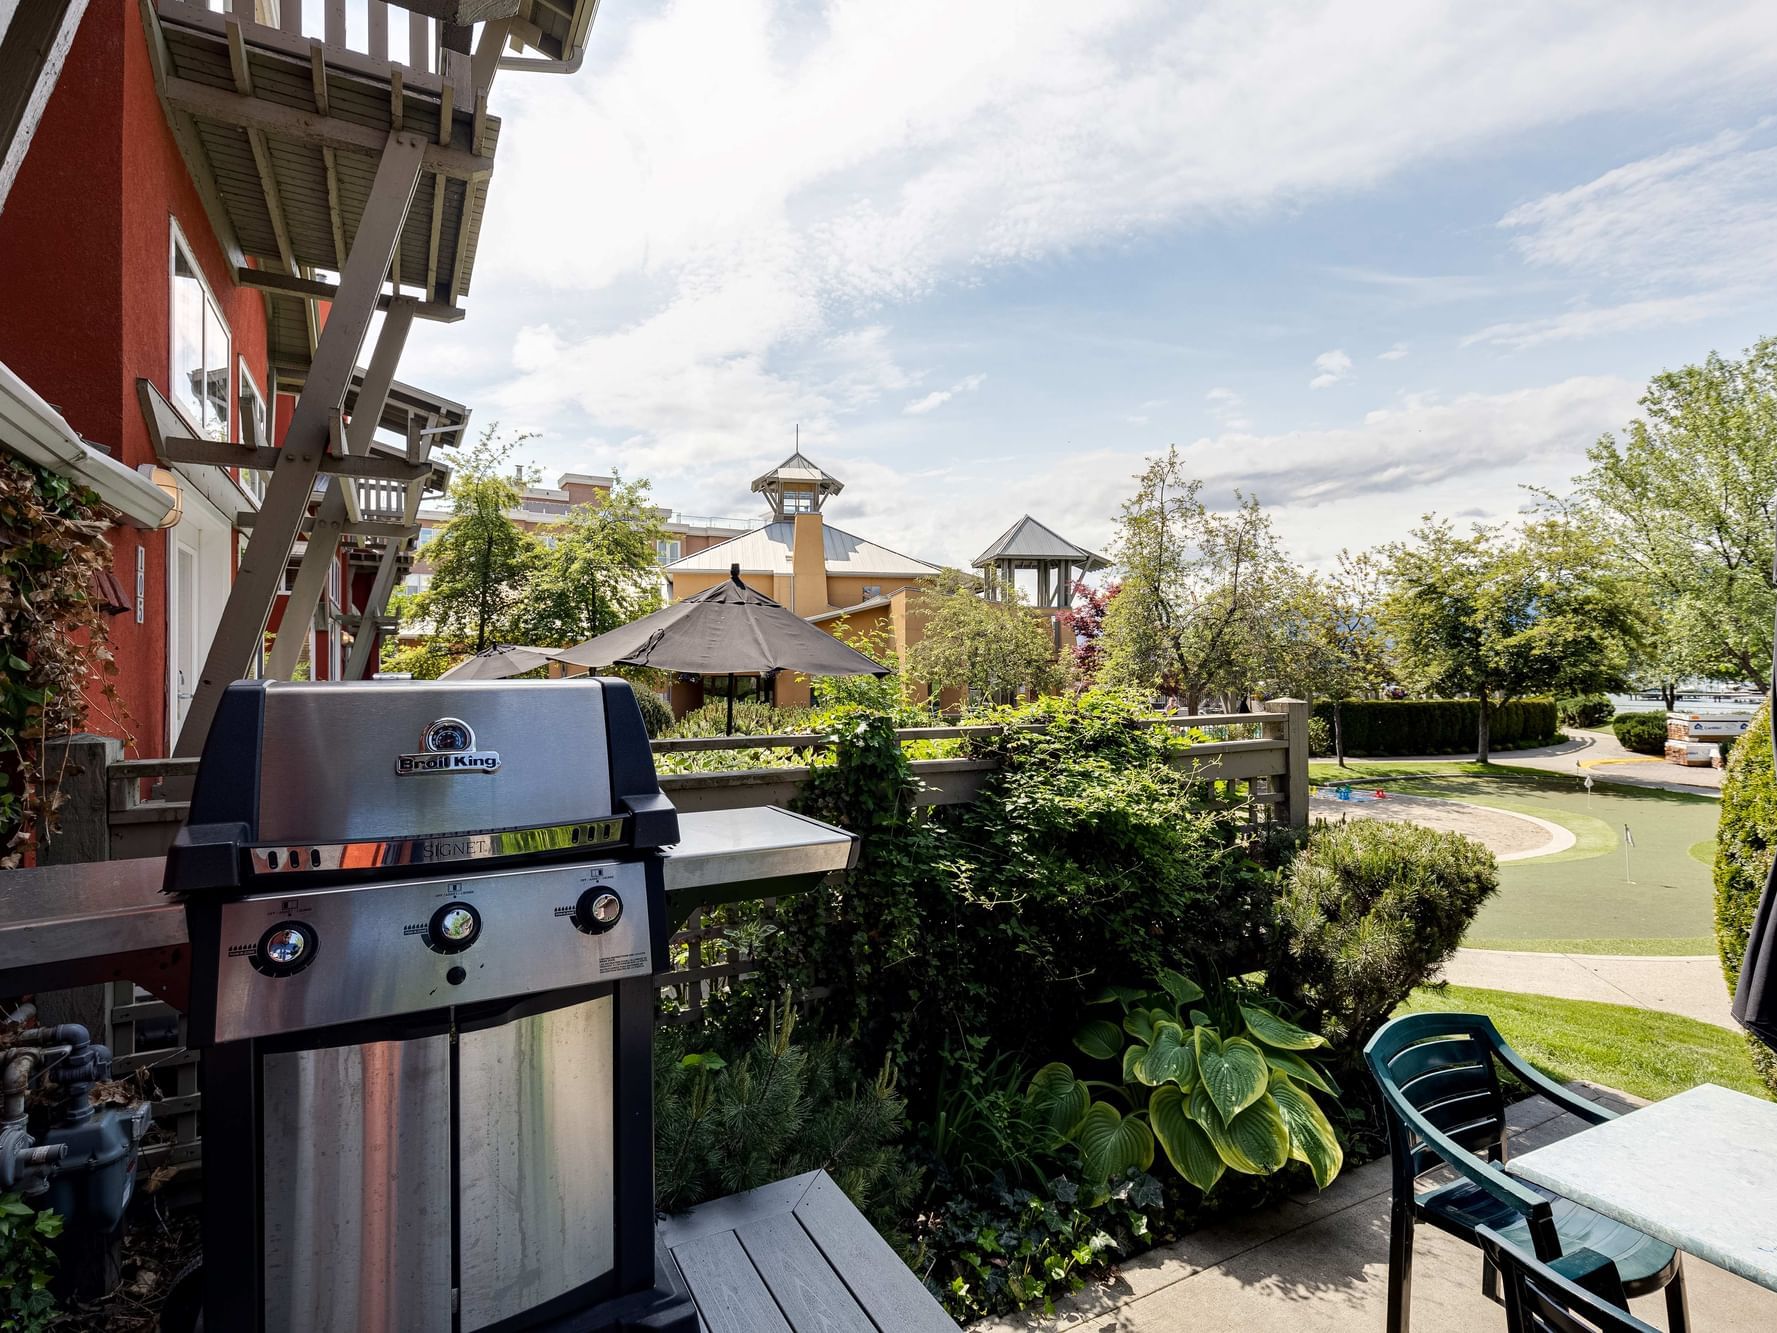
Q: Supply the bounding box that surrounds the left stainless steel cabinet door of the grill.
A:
[259,1034,451,1333]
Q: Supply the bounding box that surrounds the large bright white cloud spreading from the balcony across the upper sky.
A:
[430,0,1777,471]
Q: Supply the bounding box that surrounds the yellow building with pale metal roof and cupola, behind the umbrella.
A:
[665,450,938,713]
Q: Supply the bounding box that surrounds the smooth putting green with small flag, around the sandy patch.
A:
[1310,761,1720,954]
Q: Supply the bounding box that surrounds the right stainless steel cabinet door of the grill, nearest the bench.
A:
[457,995,617,1333]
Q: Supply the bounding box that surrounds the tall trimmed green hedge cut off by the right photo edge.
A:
[1705,704,1777,1093]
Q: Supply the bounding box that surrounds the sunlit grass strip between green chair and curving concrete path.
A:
[1398,986,1770,1100]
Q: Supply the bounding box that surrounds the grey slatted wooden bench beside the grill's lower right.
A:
[659,1171,958,1333]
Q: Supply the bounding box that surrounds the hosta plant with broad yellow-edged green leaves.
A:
[1027,970,1345,1193]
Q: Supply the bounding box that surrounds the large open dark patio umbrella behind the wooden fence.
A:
[556,565,889,736]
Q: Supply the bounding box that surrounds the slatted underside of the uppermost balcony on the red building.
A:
[147,0,499,303]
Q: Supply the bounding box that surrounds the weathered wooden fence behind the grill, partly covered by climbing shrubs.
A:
[34,700,1308,1175]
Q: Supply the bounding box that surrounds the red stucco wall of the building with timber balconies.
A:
[0,0,270,755]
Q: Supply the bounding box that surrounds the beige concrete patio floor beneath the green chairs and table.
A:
[974,1084,1777,1333]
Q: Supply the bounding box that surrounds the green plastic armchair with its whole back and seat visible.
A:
[1363,1013,1690,1333]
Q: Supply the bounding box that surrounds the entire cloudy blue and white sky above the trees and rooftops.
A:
[402,0,1777,563]
